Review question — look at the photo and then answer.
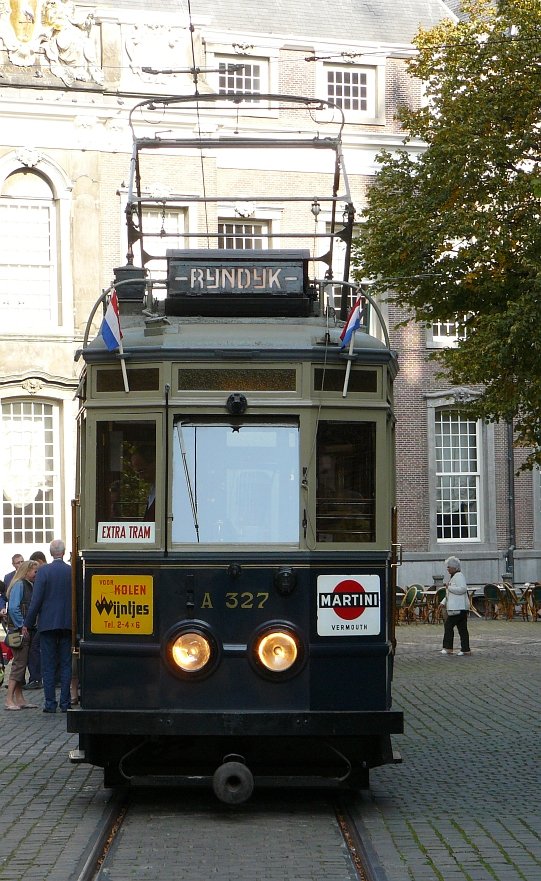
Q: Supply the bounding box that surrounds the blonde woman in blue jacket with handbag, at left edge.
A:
[4,560,38,710]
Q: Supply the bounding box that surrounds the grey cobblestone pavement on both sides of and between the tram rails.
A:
[0,618,541,881]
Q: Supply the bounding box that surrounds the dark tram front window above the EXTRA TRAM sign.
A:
[96,421,156,523]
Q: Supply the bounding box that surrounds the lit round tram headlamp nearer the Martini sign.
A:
[251,621,305,679]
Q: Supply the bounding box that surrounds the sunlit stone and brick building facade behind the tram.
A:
[0,0,541,584]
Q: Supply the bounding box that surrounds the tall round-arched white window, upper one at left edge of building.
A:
[0,169,60,330]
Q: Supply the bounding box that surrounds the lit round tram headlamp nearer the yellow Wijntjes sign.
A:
[165,621,220,679]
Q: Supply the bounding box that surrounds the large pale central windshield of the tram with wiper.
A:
[172,419,299,544]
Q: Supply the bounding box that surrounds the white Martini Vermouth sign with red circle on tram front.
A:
[317,575,381,636]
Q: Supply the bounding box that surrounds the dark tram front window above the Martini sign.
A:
[316,422,376,542]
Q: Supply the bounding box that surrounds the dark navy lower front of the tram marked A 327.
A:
[68,553,403,785]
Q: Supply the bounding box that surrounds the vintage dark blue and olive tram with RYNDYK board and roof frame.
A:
[67,94,403,803]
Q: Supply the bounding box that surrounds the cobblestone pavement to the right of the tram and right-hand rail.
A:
[359,618,541,881]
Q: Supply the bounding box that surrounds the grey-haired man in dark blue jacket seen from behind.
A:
[23,538,71,713]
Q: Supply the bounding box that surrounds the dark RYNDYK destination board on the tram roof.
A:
[167,250,307,298]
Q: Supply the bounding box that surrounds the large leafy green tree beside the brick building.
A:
[355,0,541,466]
